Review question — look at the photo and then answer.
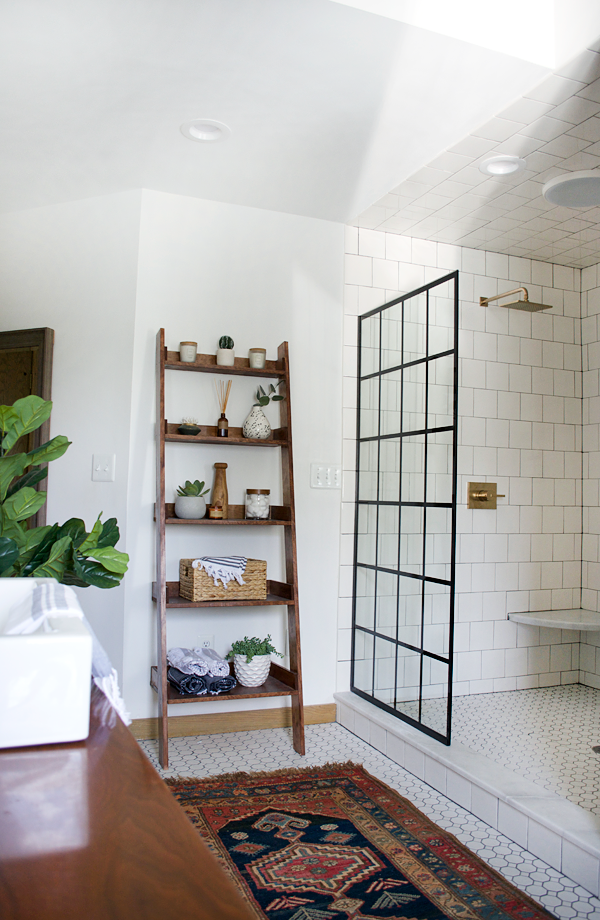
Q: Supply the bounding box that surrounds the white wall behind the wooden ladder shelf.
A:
[124,191,343,717]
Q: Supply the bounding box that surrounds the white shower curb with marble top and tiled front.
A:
[334,691,600,895]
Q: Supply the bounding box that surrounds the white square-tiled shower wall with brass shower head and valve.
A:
[338,228,597,694]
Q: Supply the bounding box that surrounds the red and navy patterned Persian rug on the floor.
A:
[167,763,552,920]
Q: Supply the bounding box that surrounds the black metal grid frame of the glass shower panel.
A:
[350,271,458,744]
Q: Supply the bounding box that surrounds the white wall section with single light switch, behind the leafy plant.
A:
[0,191,140,671]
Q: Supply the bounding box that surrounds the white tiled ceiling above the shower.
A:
[355,43,600,268]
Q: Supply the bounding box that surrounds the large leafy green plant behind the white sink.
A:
[0,396,129,588]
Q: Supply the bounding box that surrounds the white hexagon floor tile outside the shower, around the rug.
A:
[140,724,600,920]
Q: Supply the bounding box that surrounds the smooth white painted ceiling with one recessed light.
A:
[0,0,548,222]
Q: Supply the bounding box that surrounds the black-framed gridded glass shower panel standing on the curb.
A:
[351,272,458,744]
